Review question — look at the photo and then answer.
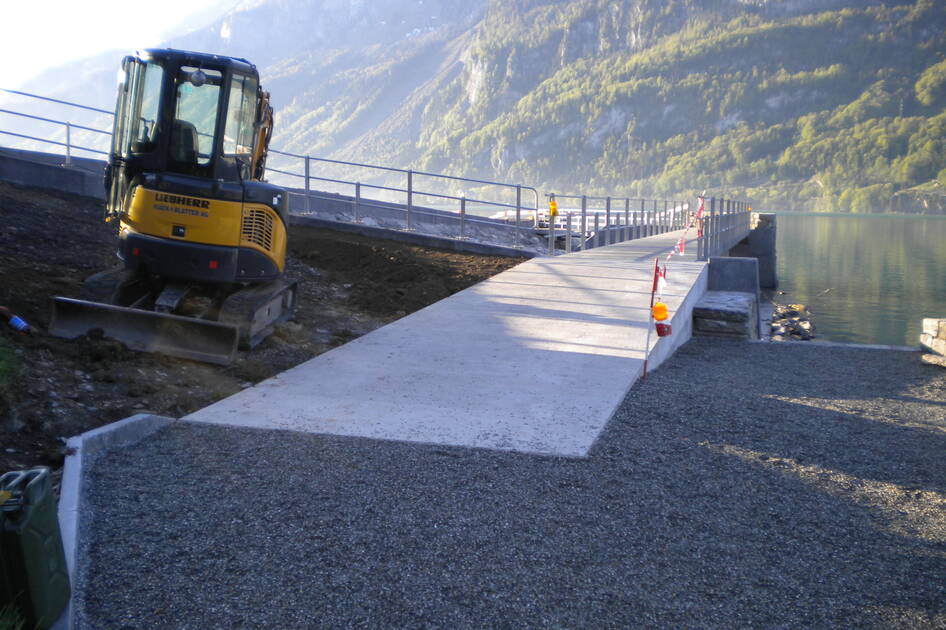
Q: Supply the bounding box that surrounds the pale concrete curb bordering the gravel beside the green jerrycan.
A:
[52,413,176,630]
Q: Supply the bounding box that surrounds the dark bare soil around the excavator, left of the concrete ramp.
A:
[0,182,521,473]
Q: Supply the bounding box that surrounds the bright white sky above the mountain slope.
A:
[0,0,237,89]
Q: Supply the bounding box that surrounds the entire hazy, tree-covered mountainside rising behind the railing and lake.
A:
[7,0,946,213]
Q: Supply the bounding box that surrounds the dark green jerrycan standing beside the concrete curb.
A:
[0,467,69,628]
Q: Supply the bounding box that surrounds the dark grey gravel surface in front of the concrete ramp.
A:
[79,339,946,630]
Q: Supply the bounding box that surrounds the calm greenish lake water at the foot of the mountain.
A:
[775,213,946,346]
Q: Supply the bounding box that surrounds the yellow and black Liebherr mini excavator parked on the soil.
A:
[50,49,296,364]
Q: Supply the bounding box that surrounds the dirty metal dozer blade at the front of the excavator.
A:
[49,297,240,365]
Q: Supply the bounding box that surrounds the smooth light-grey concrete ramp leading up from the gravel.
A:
[184,231,706,456]
